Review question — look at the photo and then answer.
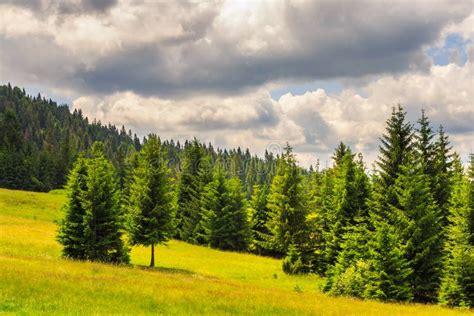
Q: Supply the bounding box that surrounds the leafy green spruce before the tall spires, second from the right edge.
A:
[391,161,442,302]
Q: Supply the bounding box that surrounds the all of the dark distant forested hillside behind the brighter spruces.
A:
[0,84,276,194]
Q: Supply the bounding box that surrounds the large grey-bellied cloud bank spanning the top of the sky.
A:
[0,0,472,98]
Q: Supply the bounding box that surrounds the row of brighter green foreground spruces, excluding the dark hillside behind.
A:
[60,107,474,307]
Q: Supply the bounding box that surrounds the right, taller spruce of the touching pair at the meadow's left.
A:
[82,143,129,263]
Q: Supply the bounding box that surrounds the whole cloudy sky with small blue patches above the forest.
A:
[0,0,474,166]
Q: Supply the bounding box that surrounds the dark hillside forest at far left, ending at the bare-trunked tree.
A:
[0,85,139,191]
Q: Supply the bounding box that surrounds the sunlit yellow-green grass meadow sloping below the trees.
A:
[0,189,469,315]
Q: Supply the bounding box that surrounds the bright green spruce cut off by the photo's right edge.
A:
[439,156,474,307]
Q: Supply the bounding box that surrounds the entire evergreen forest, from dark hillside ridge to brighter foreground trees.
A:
[0,84,474,308]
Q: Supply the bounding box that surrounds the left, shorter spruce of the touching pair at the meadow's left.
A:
[58,157,87,260]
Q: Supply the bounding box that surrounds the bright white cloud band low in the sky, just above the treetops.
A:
[74,53,474,165]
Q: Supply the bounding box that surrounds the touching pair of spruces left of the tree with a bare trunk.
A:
[58,143,129,263]
